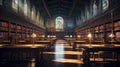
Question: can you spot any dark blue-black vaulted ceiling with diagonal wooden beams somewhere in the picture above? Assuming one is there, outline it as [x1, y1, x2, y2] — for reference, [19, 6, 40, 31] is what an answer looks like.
[30, 0, 87, 18]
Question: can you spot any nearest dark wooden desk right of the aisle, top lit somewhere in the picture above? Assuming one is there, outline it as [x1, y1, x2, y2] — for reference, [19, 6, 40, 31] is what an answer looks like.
[79, 45, 120, 62]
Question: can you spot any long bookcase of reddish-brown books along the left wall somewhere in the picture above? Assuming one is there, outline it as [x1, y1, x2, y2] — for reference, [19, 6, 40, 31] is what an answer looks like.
[0, 20, 42, 43]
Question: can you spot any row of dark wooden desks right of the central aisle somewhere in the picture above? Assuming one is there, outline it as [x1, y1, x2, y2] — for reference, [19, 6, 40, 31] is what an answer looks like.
[70, 40, 120, 62]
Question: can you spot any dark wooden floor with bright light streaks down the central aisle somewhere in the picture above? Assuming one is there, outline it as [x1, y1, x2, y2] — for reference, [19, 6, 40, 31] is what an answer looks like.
[0, 40, 120, 67]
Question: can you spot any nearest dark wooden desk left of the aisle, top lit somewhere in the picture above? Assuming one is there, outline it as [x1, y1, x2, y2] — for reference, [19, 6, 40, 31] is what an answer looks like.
[0, 44, 44, 61]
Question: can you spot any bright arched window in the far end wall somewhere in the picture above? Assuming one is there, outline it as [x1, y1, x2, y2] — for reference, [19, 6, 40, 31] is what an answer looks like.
[56, 16, 64, 31]
